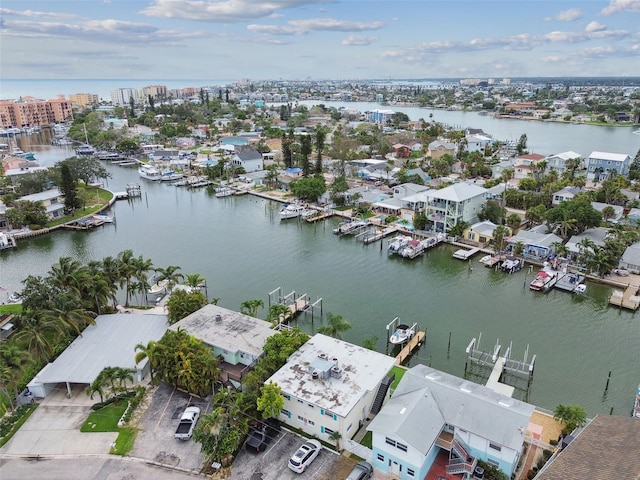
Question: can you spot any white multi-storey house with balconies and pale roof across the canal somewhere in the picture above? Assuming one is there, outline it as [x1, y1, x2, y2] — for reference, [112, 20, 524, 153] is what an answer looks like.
[425, 182, 487, 233]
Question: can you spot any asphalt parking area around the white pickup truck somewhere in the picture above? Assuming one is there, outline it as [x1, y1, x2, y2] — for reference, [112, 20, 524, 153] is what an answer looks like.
[131, 384, 210, 471]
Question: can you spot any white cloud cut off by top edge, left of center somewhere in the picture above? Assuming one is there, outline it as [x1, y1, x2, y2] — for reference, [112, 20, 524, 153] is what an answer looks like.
[140, 0, 330, 23]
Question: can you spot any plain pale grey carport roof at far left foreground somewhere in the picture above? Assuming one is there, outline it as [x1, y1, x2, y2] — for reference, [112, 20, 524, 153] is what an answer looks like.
[30, 313, 167, 384]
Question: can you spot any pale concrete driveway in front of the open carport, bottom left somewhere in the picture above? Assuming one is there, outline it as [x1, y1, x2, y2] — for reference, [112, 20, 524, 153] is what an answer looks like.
[0, 385, 118, 456]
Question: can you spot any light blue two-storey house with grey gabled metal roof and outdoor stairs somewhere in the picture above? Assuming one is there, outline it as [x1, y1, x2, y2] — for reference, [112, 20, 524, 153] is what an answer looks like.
[367, 365, 534, 480]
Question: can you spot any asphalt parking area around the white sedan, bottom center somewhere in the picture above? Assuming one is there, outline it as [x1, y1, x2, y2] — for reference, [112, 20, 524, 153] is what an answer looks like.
[229, 430, 356, 480]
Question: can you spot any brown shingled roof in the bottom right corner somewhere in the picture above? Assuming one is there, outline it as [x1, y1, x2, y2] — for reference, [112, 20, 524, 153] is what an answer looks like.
[535, 415, 640, 480]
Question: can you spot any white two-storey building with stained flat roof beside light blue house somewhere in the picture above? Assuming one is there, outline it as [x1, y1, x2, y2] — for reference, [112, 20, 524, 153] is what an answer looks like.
[266, 334, 395, 443]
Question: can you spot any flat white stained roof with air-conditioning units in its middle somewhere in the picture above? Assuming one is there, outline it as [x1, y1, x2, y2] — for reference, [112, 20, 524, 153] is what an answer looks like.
[265, 333, 395, 417]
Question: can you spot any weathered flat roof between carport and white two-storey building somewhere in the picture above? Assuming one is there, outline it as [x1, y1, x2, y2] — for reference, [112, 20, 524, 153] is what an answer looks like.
[170, 304, 277, 357]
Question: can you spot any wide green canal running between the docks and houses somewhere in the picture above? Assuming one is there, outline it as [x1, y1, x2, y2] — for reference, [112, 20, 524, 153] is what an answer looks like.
[0, 123, 640, 415]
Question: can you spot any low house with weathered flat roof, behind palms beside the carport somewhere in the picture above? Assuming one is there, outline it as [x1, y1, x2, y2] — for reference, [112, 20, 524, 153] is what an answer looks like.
[169, 304, 277, 386]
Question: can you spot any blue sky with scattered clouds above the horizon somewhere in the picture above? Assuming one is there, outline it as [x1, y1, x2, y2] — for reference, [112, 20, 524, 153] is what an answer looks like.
[0, 0, 640, 80]
